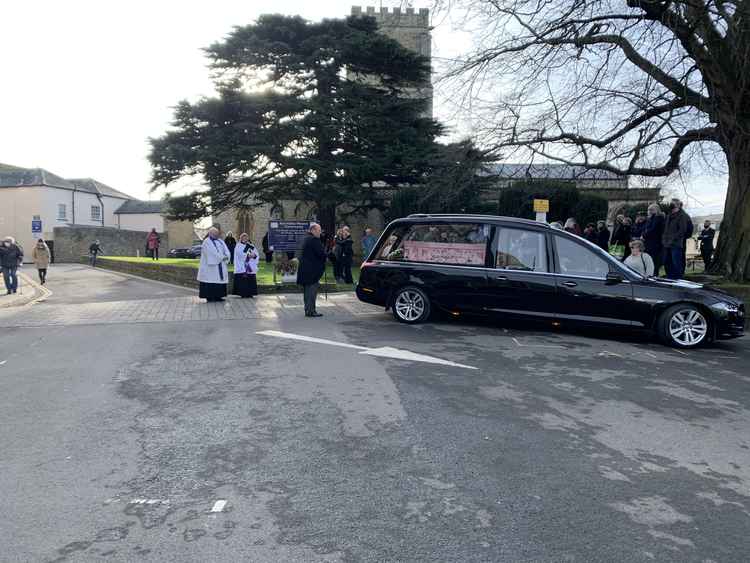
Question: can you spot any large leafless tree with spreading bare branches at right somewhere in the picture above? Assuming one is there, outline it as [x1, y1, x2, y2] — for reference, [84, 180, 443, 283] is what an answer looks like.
[446, 0, 750, 280]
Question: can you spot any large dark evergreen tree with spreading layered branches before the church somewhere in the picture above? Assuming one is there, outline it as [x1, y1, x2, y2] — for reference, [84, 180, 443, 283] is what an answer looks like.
[149, 15, 442, 234]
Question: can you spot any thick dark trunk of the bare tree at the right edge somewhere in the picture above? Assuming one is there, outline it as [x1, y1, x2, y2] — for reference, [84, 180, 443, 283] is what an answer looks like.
[711, 136, 750, 281]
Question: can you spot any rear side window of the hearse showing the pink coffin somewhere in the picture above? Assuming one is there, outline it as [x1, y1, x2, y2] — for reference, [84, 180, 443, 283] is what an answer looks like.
[377, 223, 490, 266]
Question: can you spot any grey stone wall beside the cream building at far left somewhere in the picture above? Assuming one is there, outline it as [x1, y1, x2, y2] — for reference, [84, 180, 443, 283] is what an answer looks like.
[53, 225, 169, 262]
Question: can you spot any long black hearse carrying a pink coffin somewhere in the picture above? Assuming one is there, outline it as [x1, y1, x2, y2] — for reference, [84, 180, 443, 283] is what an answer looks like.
[357, 215, 745, 348]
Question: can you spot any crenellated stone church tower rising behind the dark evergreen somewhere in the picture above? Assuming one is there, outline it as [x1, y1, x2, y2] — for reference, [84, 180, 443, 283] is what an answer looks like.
[352, 6, 433, 117]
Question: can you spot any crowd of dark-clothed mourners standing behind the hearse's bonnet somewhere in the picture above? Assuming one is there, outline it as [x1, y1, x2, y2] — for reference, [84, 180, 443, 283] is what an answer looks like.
[552, 199, 716, 279]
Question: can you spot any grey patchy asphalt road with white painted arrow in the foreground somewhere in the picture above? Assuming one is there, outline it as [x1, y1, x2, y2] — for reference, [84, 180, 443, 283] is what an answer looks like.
[0, 267, 750, 562]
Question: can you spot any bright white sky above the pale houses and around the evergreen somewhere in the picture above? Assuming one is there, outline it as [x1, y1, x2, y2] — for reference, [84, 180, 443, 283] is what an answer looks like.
[0, 0, 725, 213]
